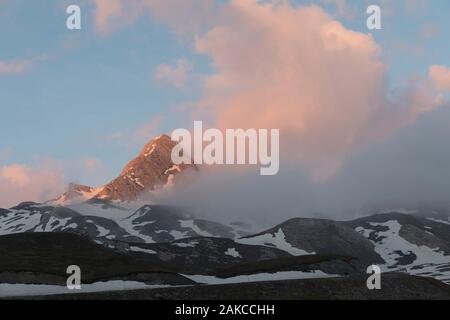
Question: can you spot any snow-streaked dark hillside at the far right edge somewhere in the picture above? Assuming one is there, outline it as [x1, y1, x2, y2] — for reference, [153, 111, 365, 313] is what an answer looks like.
[349, 212, 450, 283]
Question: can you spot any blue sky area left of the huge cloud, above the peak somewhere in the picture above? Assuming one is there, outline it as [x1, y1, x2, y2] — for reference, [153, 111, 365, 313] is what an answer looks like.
[0, 1, 200, 182]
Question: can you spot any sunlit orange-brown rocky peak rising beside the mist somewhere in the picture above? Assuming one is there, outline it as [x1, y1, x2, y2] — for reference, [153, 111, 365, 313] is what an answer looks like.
[95, 135, 197, 201]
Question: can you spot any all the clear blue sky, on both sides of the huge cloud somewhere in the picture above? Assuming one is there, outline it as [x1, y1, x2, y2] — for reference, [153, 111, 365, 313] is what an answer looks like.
[0, 0, 450, 183]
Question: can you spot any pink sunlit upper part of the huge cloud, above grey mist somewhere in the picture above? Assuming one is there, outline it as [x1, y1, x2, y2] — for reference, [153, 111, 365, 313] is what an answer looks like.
[191, 0, 442, 179]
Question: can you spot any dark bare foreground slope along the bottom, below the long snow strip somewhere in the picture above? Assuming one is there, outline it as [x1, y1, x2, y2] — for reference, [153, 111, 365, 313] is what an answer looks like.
[12, 273, 450, 300]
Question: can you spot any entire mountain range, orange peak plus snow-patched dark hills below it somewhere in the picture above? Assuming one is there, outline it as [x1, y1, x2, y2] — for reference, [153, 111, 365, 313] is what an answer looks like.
[0, 135, 450, 296]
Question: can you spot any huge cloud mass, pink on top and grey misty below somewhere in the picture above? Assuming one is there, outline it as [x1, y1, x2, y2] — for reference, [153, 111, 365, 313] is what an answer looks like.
[146, 1, 450, 222]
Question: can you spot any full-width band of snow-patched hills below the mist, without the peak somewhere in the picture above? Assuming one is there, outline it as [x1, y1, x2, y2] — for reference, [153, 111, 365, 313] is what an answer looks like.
[0, 199, 450, 283]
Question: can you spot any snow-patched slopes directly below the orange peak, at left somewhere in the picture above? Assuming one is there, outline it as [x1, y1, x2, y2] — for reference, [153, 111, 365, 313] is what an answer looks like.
[0, 200, 243, 243]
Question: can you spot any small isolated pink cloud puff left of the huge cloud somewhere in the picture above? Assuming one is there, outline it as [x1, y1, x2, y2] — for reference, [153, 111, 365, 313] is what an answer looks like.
[155, 59, 192, 89]
